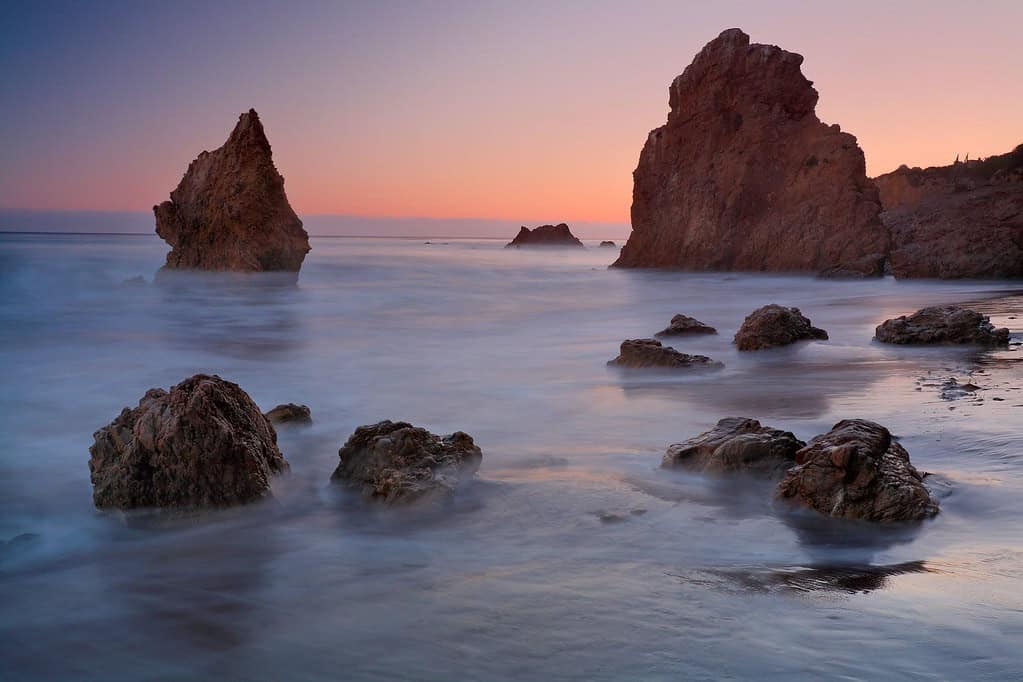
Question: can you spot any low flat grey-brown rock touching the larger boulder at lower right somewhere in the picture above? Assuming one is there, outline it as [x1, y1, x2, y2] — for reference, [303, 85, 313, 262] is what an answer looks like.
[661, 417, 806, 476]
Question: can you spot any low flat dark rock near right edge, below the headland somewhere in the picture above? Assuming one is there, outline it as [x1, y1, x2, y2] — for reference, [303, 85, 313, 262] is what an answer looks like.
[874, 306, 1009, 346]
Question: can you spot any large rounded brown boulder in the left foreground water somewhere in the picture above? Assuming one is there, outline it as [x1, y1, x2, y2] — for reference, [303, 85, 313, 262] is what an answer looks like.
[89, 374, 287, 509]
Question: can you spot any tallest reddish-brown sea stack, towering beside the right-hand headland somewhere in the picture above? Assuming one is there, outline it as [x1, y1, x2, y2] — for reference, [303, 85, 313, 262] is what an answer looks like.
[615, 29, 888, 275]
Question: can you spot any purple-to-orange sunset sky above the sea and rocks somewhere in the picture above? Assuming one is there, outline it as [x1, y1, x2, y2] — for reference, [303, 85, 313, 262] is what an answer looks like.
[0, 0, 1023, 229]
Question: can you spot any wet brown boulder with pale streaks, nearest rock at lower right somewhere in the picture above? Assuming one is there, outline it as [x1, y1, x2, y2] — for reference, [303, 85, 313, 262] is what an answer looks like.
[777, 419, 938, 521]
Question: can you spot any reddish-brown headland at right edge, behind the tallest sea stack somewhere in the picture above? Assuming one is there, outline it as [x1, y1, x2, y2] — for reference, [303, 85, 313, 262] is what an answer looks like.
[875, 145, 1023, 279]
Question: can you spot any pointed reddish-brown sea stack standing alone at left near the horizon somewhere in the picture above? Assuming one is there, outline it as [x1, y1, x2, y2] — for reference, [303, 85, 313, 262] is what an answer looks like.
[152, 109, 309, 272]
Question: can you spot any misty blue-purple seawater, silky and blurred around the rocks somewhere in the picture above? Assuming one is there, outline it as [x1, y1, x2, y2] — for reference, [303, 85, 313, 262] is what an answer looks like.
[0, 234, 1023, 681]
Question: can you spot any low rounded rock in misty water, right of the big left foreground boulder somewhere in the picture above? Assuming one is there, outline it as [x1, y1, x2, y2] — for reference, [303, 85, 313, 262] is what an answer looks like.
[330, 421, 483, 502]
